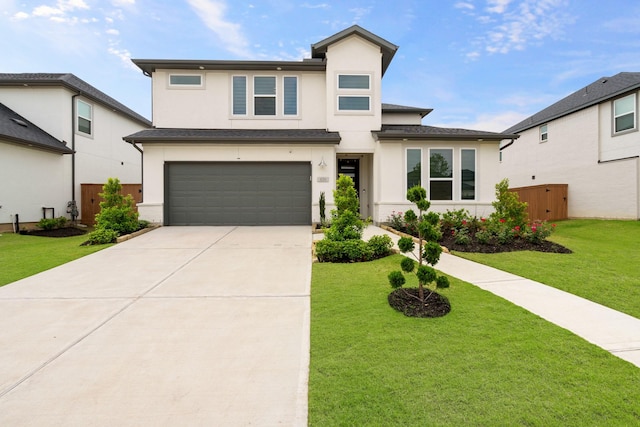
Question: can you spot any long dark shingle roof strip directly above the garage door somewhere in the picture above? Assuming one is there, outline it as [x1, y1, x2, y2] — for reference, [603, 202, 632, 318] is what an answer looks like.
[123, 128, 340, 144]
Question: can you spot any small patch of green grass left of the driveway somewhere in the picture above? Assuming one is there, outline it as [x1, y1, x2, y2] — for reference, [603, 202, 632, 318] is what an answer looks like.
[0, 233, 110, 286]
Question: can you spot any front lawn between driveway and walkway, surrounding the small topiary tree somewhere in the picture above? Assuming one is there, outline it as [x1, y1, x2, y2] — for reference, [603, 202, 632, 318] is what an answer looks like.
[309, 255, 640, 426]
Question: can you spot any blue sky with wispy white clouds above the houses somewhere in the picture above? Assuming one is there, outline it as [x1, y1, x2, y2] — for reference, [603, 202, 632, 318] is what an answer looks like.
[0, 0, 640, 131]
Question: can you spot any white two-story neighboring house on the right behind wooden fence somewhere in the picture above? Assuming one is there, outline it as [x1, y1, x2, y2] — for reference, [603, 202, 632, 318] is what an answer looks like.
[500, 73, 640, 219]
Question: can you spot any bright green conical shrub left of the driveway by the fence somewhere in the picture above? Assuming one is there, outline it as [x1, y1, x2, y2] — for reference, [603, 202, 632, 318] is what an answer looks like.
[96, 178, 140, 235]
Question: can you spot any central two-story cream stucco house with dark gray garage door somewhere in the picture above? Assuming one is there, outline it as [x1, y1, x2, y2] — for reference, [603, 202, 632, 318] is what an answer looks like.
[125, 26, 517, 225]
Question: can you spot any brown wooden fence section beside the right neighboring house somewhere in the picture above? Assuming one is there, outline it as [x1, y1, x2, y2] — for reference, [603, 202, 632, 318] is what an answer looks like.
[509, 184, 569, 221]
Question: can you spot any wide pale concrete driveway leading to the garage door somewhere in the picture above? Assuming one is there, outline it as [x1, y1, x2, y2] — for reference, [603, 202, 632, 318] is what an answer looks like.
[0, 227, 311, 426]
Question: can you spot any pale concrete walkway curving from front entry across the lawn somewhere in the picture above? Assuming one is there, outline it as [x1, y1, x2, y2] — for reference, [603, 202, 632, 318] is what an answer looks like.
[363, 226, 640, 367]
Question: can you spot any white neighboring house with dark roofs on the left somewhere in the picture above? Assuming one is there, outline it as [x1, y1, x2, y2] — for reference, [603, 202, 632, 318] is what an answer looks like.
[0, 73, 151, 229]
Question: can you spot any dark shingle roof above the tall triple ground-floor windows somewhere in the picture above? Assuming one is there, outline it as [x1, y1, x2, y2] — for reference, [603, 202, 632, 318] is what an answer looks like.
[374, 125, 519, 141]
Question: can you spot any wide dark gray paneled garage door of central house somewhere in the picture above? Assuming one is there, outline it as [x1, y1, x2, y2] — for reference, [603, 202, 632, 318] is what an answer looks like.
[164, 162, 311, 225]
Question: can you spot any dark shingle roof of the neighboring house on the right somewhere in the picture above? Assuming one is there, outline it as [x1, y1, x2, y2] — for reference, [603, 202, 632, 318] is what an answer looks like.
[505, 73, 640, 133]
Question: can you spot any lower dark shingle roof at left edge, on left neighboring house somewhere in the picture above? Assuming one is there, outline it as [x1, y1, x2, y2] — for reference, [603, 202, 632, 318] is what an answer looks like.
[0, 103, 73, 154]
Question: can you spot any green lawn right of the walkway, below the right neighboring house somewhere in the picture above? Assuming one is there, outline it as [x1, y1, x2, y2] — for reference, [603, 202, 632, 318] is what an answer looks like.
[456, 220, 640, 318]
